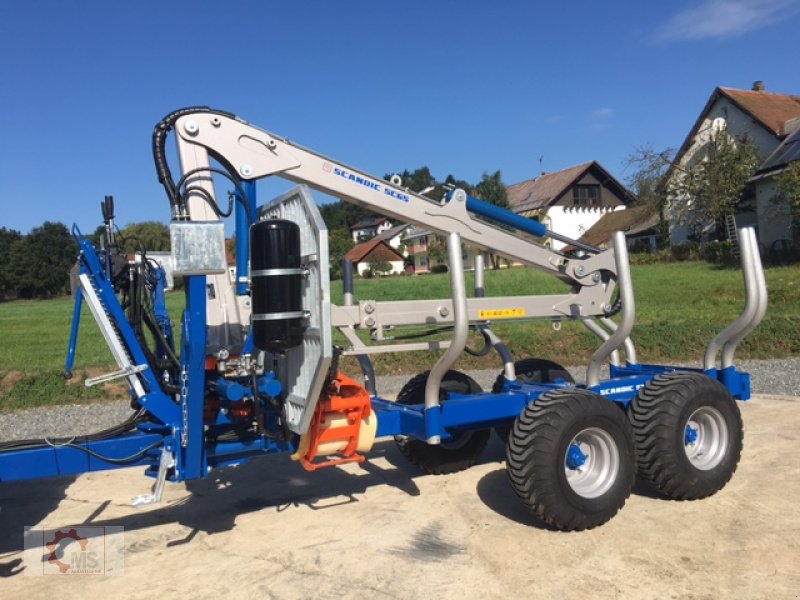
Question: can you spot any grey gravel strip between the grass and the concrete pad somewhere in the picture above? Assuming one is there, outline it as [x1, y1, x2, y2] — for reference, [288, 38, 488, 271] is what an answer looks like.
[0, 358, 800, 441]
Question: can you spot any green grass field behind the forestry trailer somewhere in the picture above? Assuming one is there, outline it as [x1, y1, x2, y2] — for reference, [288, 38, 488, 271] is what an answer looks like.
[0, 263, 800, 412]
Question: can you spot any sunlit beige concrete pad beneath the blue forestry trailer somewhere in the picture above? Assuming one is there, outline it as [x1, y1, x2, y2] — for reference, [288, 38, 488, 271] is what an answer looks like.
[0, 396, 800, 600]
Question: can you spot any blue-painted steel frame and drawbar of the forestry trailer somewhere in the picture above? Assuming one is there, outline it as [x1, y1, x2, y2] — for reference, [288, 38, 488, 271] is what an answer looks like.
[0, 209, 750, 482]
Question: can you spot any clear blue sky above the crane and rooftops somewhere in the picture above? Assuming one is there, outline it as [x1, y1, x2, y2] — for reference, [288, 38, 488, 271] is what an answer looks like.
[0, 0, 800, 233]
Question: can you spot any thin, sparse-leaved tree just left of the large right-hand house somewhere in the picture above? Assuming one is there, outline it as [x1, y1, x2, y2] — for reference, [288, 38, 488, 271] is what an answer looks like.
[626, 146, 675, 248]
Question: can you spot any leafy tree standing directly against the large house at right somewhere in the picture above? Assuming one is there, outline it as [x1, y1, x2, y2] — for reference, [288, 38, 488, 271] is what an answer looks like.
[671, 131, 761, 241]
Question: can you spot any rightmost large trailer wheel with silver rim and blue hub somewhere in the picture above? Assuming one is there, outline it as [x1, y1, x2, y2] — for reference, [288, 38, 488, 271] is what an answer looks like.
[628, 373, 744, 500]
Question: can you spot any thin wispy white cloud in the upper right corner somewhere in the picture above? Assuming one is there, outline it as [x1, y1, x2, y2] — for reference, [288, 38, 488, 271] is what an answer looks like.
[656, 0, 797, 41]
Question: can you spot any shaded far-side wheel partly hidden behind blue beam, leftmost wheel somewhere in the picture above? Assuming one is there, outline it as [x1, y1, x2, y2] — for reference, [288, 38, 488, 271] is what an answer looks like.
[395, 371, 491, 475]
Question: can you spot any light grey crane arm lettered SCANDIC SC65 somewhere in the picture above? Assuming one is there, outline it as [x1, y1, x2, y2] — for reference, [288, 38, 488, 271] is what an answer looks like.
[164, 110, 616, 302]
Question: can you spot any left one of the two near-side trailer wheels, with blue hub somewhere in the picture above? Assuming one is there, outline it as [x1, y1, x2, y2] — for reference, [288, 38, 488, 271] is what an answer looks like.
[506, 389, 635, 531]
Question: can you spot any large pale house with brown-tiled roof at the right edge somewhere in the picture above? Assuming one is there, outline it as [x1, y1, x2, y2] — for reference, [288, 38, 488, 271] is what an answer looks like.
[668, 81, 800, 249]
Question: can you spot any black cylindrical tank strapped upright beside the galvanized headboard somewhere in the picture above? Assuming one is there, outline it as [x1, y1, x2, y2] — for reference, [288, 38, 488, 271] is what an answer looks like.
[250, 219, 306, 352]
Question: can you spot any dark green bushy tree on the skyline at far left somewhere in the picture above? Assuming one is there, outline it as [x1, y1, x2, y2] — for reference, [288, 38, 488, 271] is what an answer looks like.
[9, 221, 77, 298]
